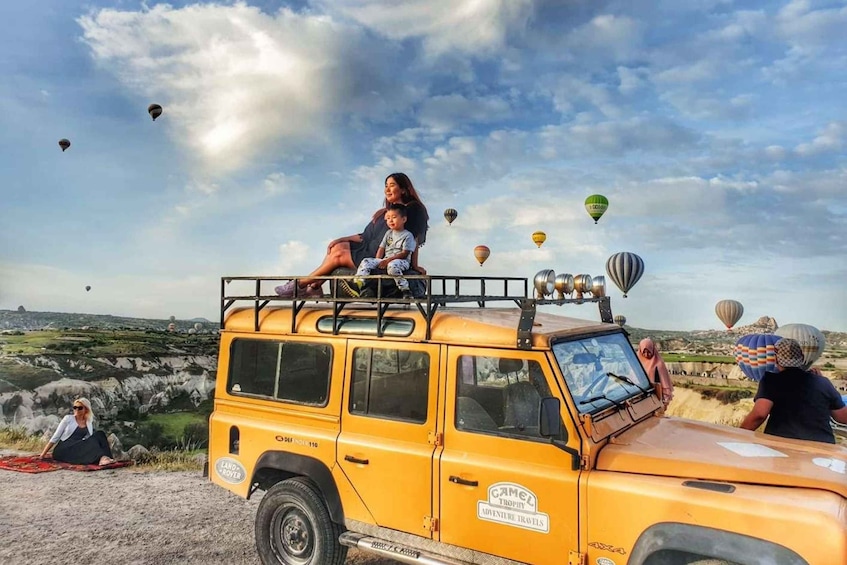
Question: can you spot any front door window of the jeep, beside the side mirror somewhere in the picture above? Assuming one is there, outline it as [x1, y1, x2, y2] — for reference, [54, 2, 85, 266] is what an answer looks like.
[455, 355, 552, 441]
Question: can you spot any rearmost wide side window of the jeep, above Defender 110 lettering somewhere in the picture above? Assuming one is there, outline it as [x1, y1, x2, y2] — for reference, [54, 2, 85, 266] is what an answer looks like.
[227, 339, 332, 406]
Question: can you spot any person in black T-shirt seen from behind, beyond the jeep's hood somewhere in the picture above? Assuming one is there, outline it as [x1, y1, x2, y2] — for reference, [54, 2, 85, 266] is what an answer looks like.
[740, 338, 847, 443]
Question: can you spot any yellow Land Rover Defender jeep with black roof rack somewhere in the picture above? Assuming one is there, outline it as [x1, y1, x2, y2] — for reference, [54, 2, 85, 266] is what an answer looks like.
[208, 276, 847, 565]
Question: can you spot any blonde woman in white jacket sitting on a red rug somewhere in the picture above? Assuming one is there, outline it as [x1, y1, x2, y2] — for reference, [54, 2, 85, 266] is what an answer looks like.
[39, 398, 115, 465]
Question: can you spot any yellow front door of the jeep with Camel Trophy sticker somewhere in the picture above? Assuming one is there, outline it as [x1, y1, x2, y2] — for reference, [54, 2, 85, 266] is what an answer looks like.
[436, 347, 579, 565]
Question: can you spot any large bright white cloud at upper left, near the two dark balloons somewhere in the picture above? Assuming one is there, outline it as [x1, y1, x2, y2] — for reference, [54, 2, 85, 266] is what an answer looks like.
[79, 2, 408, 174]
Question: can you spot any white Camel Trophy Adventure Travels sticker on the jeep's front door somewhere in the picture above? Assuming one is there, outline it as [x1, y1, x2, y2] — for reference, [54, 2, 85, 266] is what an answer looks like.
[476, 483, 550, 534]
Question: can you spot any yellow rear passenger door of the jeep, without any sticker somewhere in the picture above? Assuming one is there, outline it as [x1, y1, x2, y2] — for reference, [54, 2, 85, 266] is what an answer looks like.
[337, 340, 439, 535]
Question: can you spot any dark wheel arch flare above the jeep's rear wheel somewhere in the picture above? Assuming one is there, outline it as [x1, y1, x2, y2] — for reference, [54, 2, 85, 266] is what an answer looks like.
[248, 451, 344, 524]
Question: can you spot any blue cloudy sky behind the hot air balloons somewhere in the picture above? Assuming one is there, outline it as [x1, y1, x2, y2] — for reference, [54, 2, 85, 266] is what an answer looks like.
[0, 0, 847, 331]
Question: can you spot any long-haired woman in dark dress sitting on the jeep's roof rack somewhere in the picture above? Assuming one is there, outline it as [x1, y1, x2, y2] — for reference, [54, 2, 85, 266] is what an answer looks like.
[275, 173, 429, 298]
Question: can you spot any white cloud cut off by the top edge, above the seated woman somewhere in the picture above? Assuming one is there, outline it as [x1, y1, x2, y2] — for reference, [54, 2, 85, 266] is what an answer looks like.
[316, 0, 532, 56]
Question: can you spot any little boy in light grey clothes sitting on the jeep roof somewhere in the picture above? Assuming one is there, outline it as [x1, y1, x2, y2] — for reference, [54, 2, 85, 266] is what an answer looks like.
[353, 203, 417, 298]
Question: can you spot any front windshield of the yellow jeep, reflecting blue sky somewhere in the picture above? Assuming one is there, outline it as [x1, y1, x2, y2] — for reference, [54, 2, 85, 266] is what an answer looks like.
[553, 333, 653, 413]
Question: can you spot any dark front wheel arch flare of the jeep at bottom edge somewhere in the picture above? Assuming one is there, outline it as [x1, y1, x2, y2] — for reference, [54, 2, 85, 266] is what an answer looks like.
[627, 522, 809, 565]
